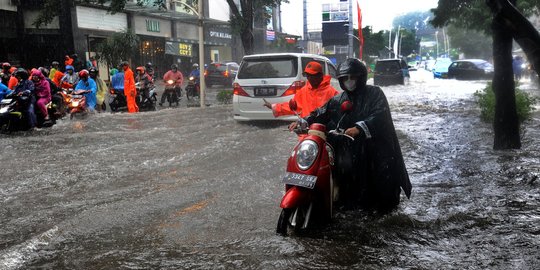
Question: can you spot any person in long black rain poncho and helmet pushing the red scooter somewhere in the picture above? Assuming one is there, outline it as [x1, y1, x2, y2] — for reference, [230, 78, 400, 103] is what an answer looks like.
[304, 58, 411, 213]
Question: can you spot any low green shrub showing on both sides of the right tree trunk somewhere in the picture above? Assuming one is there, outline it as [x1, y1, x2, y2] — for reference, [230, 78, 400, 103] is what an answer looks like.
[474, 83, 537, 123]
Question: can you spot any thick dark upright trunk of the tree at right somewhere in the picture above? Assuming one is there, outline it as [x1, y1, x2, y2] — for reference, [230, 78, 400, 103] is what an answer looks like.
[492, 0, 521, 149]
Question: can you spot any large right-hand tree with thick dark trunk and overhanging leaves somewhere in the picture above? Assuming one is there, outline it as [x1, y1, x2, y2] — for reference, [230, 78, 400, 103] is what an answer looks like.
[431, 0, 540, 149]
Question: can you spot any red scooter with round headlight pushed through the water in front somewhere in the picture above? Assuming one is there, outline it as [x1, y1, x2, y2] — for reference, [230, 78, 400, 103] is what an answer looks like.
[276, 100, 354, 235]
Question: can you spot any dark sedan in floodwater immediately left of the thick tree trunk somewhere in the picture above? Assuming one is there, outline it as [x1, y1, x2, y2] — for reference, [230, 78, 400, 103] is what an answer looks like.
[448, 59, 493, 80]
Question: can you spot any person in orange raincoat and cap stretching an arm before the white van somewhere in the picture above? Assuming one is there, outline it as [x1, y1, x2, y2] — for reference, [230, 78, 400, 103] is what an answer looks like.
[264, 61, 338, 117]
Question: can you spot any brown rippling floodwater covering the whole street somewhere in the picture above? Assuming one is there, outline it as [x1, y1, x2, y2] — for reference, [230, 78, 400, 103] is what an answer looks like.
[0, 70, 540, 269]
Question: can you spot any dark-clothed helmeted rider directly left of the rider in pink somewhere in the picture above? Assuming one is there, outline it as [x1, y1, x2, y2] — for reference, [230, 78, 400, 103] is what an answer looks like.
[12, 68, 37, 129]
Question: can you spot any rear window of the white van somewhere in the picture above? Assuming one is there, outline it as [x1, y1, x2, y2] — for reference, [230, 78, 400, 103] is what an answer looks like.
[238, 57, 298, 79]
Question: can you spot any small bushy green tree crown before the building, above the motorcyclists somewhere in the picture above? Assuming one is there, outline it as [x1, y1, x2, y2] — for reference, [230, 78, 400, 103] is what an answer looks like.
[96, 30, 139, 67]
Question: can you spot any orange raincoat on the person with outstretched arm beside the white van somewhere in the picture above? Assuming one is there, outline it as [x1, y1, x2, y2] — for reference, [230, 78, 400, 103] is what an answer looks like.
[272, 75, 338, 117]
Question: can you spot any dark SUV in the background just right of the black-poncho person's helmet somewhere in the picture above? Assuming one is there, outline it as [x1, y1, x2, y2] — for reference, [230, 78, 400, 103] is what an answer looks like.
[373, 58, 410, 86]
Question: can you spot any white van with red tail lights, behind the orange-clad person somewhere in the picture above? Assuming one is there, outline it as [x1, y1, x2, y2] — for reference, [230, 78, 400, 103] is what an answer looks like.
[232, 53, 340, 121]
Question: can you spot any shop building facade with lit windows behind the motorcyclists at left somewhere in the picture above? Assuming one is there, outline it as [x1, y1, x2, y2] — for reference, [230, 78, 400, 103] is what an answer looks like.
[0, 0, 241, 76]
